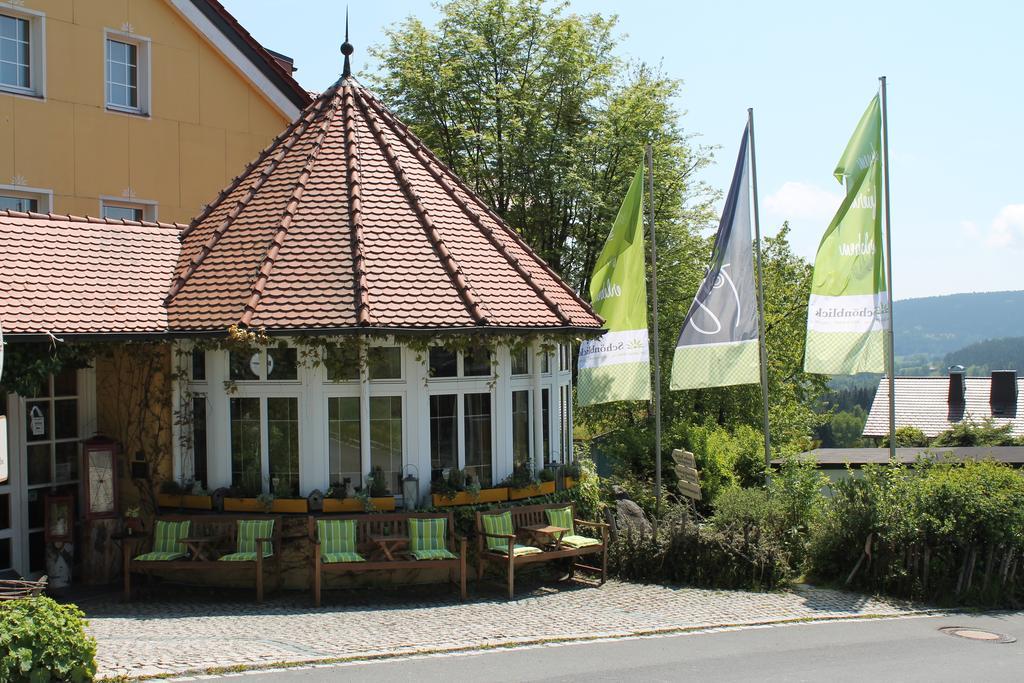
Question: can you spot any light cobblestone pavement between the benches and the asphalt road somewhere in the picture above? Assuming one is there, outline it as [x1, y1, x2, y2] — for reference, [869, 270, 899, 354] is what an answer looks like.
[80, 582, 921, 677]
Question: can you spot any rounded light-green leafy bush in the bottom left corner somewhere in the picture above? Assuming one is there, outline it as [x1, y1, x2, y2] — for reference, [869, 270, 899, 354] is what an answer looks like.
[0, 598, 96, 681]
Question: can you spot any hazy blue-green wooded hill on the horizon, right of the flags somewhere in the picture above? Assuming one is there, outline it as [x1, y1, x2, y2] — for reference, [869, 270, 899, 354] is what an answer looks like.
[893, 292, 1024, 358]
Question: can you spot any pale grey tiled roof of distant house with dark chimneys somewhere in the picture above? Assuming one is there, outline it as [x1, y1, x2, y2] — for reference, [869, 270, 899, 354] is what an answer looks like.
[863, 377, 1024, 436]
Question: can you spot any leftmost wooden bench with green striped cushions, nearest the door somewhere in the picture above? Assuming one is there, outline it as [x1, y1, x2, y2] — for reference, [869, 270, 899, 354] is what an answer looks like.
[124, 514, 282, 602]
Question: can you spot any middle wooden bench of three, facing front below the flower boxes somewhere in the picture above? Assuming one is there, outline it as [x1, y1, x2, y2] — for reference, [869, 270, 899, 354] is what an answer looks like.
[309, 512, 466, 607]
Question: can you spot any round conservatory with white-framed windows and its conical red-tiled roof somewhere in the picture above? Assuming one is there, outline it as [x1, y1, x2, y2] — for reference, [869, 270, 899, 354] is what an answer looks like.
[166, 72, 601, 505]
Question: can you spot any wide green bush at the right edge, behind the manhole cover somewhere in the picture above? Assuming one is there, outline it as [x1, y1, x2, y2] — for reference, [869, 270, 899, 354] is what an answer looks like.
[808, 461, 1024, 605]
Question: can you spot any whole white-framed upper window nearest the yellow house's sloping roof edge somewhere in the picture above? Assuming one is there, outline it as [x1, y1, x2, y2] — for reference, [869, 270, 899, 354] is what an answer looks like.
[103, 30, 150, 116]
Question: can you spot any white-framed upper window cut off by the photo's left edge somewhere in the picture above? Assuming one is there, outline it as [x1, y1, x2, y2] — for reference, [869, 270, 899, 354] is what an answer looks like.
[0, 5, 46, 97]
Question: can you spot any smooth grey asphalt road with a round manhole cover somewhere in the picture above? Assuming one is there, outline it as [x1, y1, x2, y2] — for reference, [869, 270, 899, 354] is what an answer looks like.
[237, 612, 1024, 683]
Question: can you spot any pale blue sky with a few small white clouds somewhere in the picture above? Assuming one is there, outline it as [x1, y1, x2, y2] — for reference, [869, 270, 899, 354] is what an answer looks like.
[224, 0, 1024, 299]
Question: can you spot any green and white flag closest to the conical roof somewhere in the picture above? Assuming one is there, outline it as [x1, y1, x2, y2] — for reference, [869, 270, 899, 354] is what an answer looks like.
[577, 164, 650, 405]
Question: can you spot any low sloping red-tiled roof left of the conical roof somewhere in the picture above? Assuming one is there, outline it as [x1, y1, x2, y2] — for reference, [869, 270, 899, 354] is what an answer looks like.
[0, 211, 185, 335]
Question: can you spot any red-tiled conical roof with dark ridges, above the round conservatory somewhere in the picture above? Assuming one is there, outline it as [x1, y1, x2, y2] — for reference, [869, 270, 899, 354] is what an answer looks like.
[167, 77, 601, 332]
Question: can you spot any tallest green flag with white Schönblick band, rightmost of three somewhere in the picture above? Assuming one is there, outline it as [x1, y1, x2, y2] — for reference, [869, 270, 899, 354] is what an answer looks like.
[804, 96, 889, 375]
